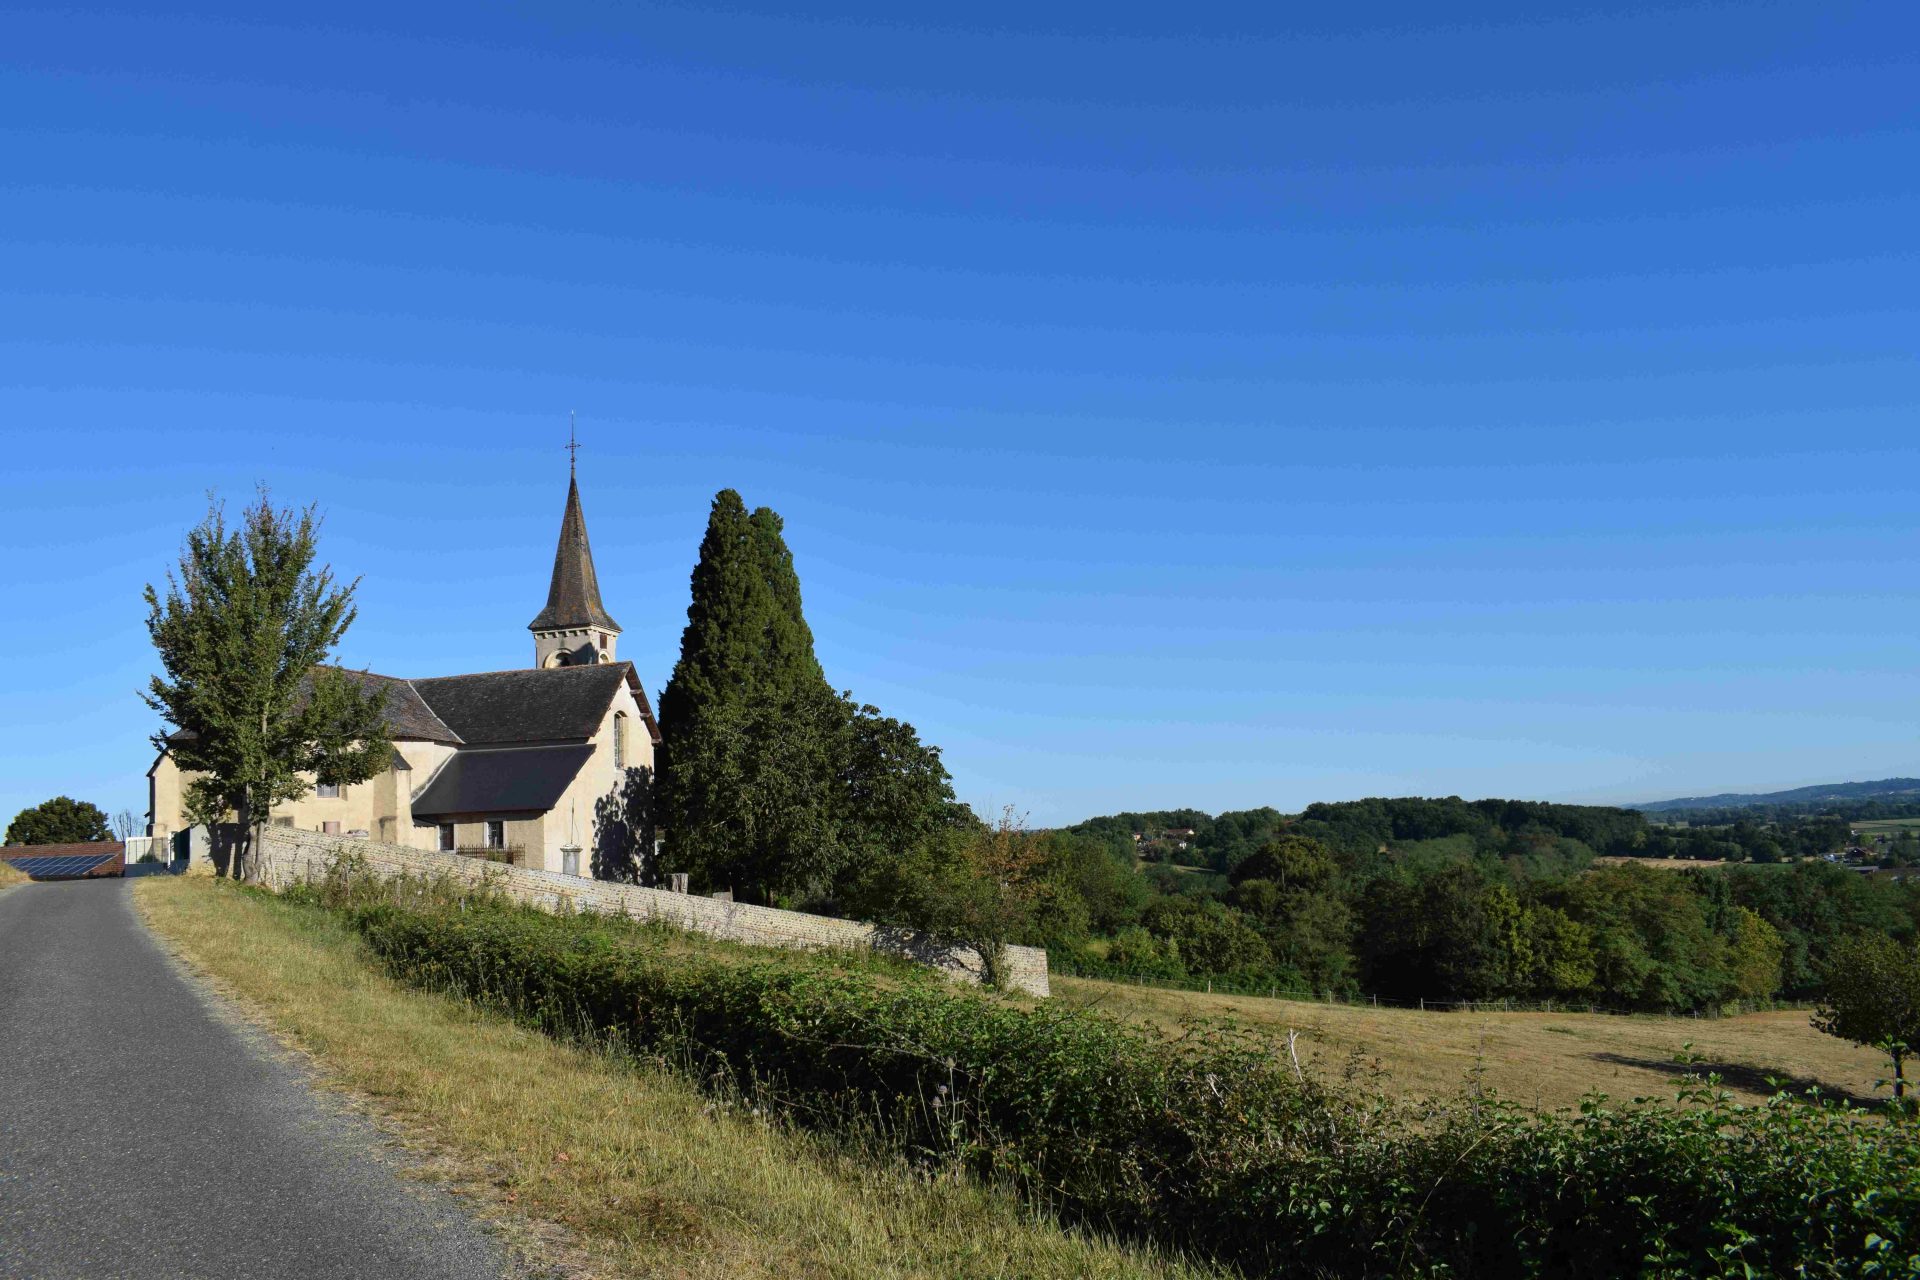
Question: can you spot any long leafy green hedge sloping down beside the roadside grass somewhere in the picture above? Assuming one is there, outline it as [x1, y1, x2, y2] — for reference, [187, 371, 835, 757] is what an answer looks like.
[326, 904, 1920, 1276]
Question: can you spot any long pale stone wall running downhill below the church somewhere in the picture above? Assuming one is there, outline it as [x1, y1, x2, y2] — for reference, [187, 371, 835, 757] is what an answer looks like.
[255, 827, 1050, 996]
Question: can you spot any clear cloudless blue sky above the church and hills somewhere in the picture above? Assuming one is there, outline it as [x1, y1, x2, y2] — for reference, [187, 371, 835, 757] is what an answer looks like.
[0, 4, 1920, 823]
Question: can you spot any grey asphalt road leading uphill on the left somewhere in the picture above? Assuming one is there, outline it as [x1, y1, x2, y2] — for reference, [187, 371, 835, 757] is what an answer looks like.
[0, 881, 513, 1280]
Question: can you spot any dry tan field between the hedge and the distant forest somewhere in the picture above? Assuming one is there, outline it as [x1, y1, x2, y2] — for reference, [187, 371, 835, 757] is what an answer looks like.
[1052, 975, 1885, 1109]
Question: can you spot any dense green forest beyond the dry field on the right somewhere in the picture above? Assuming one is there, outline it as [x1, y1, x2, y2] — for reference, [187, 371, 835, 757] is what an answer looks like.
[1021, 796, 1920, 1011]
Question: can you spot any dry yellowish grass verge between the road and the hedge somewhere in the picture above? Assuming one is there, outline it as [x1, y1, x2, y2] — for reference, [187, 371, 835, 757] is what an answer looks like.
[134, 877, 1212, 1280]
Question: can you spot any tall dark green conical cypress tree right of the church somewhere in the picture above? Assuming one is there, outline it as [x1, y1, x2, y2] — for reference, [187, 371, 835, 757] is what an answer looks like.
[659, 489, 839, 898]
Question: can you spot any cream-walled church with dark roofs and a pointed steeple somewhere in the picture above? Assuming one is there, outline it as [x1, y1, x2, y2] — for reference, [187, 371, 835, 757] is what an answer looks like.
[148, 478, 660, 875]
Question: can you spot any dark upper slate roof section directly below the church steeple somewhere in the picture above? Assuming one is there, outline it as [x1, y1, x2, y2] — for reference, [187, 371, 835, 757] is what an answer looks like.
[413, 662, 633, 747]
